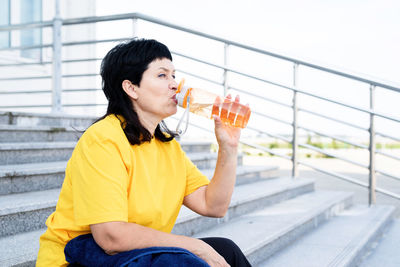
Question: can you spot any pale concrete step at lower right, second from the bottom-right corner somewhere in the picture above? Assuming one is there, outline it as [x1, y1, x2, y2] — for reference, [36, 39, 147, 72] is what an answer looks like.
[259, 205, 394, 267]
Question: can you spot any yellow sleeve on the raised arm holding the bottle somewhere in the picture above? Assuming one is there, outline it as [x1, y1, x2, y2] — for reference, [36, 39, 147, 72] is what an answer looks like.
[182, 151, 210, 196]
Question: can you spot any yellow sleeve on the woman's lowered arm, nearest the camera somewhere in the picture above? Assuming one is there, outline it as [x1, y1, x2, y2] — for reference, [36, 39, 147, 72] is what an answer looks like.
[67, 138, 128, 225]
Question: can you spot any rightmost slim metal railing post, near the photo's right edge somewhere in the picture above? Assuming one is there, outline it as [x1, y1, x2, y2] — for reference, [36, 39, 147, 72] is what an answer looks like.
[368, 84, 376, 206]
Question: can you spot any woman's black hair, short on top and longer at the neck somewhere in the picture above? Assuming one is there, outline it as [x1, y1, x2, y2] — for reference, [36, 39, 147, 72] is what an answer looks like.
[99, 38, 177, 145]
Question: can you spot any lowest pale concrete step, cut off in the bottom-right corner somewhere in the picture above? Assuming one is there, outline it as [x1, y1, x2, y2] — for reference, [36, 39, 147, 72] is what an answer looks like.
[359, 219, 400, 267]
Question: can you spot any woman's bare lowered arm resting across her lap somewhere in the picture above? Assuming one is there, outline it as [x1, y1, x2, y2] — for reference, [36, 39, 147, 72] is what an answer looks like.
[90, 222, 228, 266]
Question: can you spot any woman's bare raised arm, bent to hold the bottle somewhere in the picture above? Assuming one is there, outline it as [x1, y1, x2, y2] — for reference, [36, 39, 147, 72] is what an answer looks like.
[183, 97, 240, 217]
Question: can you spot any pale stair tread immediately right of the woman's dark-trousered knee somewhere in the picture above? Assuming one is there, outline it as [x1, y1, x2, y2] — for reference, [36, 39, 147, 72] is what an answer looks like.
[196, 191, 352, 255]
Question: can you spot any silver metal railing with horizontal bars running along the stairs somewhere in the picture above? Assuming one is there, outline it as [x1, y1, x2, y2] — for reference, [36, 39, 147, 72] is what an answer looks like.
[0, 12, 400, 204]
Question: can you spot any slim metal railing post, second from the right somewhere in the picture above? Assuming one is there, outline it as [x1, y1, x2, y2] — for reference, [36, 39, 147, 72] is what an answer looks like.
[292, 63, 299, 178]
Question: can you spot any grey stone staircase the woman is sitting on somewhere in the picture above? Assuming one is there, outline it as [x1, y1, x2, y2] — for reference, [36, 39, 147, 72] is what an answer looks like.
[0, 112, 400, 267]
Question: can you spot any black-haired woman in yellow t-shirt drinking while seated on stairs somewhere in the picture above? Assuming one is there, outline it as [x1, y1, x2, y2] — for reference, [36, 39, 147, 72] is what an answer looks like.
[37, 39, 249, 266]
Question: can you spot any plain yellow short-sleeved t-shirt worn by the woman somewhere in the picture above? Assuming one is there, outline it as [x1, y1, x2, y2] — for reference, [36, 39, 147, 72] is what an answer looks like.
[36, 115, 209, 266]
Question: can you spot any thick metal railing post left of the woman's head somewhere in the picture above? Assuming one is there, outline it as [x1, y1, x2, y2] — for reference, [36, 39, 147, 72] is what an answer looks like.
[52, 0, 62, 113]
